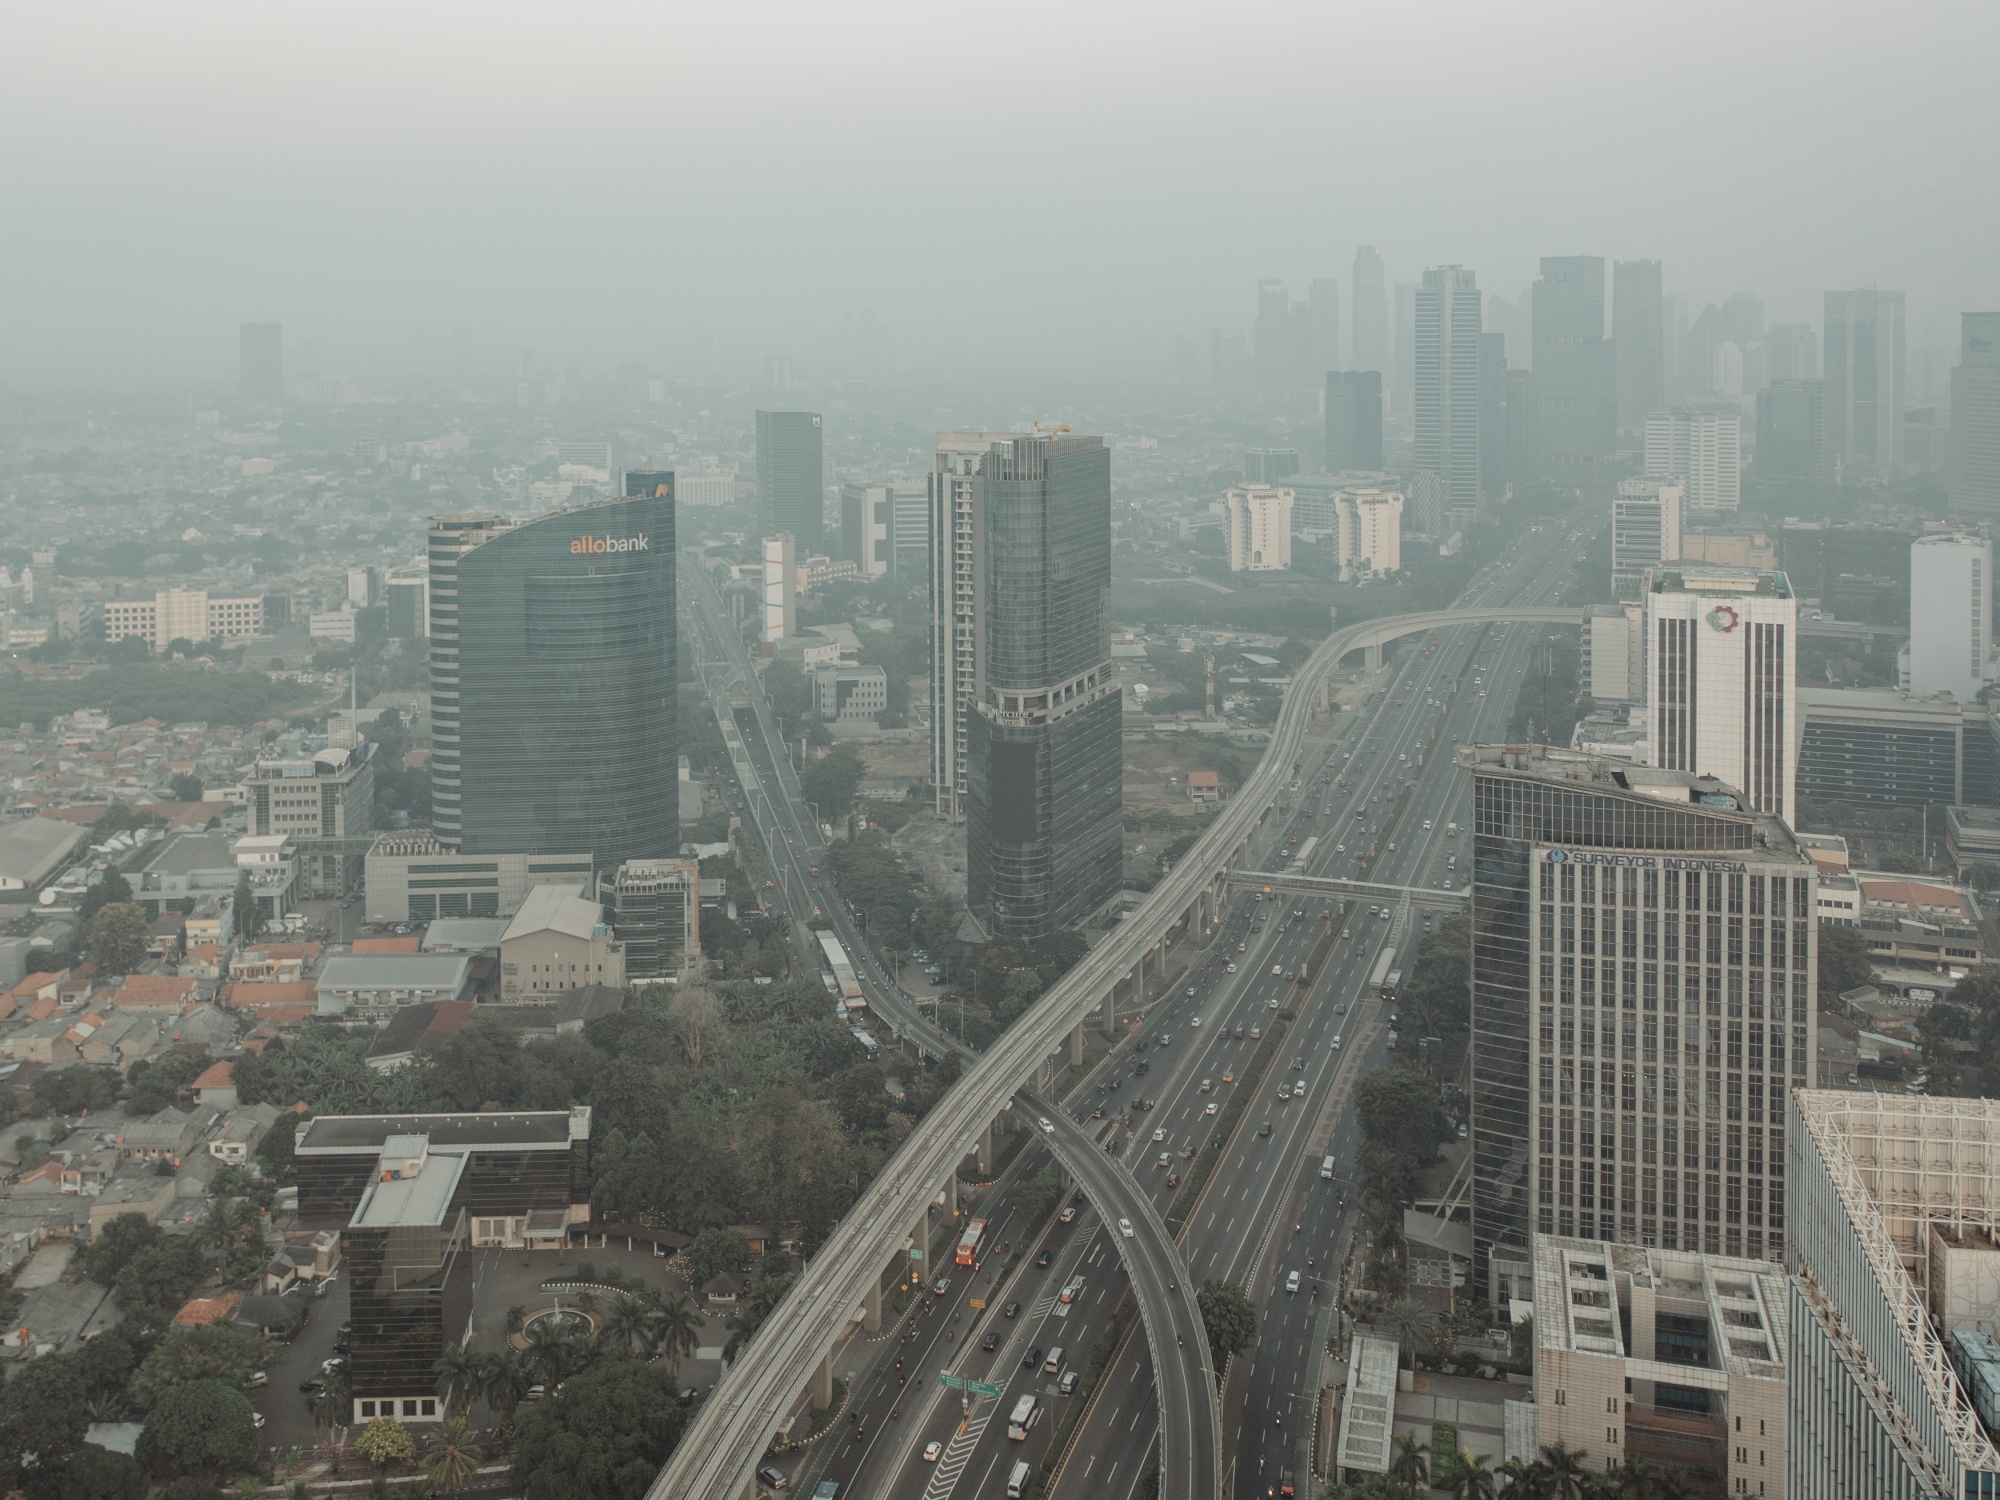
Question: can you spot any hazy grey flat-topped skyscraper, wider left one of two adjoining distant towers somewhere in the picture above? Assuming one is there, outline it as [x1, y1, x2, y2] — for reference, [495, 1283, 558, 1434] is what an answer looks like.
[1534, 256, 1618, 492]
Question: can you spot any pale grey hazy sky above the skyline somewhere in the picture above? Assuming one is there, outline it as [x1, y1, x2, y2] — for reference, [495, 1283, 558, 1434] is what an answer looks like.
[0, 0, 2000, 386]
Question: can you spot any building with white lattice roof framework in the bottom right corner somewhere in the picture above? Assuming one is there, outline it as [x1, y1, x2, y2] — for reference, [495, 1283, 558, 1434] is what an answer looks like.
[1782, 1088, 2000, 1500]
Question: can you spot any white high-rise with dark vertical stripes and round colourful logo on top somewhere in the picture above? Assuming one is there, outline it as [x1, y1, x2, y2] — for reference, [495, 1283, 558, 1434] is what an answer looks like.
[1644, 562, 1798, 822]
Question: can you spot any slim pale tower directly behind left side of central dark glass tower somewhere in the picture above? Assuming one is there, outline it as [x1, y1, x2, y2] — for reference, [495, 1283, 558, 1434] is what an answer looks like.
[930, 432, 1020, 822]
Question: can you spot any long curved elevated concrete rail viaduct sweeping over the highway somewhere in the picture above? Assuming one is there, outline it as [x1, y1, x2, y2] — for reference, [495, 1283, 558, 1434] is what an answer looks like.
[646, 608, 1582, 1500]
